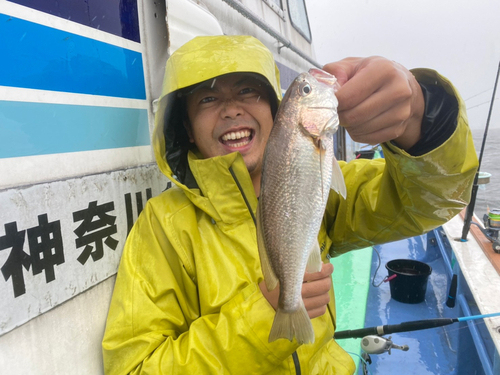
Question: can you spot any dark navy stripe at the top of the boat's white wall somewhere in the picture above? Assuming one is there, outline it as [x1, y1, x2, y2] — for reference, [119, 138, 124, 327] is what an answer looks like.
[5, 0, 140, 42]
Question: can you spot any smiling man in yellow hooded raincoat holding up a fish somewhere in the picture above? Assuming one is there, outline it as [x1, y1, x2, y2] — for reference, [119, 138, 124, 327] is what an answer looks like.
[103, 36, 478, 375]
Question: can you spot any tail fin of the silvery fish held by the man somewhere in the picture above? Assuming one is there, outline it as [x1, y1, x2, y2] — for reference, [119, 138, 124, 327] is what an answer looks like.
[269, 303, 314, 344]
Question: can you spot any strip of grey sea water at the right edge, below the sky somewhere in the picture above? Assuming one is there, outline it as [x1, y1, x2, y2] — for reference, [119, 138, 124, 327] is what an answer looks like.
[472, 125, 500, 220]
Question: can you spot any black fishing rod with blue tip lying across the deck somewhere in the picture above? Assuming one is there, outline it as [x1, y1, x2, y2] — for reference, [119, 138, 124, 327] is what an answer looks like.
[333, 312, 500, 340]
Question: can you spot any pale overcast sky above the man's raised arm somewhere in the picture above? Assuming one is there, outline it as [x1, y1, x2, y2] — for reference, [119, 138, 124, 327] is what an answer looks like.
[306, 0, 500, 129]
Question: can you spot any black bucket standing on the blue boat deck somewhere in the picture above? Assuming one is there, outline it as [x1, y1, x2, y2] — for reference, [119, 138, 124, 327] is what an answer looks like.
[385, 259, 432, 303]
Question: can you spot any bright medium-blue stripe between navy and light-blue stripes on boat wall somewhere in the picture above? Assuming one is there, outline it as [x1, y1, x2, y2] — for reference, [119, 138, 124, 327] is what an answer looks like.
[0, 14, 146, 99]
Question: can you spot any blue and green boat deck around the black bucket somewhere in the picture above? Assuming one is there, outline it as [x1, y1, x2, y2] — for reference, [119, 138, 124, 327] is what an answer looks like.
[332, 219, 500, 375]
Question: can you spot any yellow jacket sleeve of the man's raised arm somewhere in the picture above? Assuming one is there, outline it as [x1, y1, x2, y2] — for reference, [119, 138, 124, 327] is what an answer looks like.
[326, 69, 478, 256]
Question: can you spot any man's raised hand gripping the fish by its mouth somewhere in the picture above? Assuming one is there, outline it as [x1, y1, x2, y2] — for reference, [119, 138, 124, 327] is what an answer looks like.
[324, 56, 424, 149]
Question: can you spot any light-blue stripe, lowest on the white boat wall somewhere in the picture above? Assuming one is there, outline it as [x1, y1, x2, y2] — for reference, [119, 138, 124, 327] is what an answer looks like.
[0, 101, 150, 158]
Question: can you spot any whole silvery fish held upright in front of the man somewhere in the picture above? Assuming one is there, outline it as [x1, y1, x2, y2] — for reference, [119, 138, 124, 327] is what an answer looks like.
[257, 69, 346, 343]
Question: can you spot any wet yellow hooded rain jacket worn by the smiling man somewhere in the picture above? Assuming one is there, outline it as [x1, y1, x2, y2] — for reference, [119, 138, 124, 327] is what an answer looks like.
[103, 36, 477, 375]
